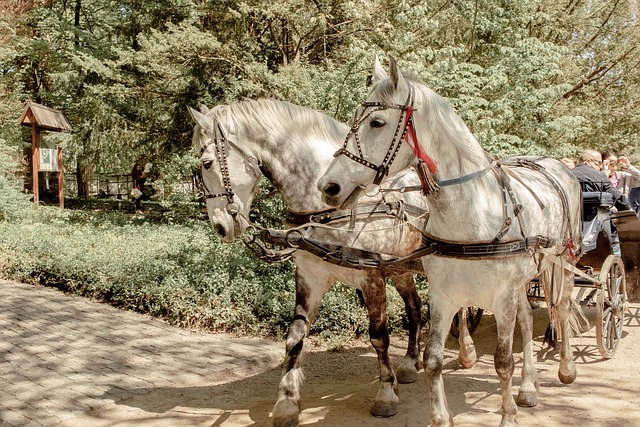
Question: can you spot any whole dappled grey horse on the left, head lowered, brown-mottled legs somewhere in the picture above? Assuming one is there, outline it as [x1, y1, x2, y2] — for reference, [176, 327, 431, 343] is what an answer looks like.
[189, 100, 442, 426]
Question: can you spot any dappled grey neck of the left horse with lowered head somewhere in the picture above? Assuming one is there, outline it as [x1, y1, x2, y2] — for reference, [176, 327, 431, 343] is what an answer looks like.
[230, 107, 346, 212]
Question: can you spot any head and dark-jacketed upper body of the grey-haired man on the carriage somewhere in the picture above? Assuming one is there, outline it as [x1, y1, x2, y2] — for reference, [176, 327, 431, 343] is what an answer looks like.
[572, 150, 631, 211]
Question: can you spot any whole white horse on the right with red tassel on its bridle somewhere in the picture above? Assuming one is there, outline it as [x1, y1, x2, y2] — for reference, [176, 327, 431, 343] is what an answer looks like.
[318, 59, 581, 426]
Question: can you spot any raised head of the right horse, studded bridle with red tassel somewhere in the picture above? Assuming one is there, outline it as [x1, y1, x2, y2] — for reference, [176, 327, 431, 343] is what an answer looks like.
[318, 57, 417, 206]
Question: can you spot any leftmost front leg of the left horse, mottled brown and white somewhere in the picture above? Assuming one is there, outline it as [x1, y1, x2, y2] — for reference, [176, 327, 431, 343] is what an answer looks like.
[272, 265, 331, 427]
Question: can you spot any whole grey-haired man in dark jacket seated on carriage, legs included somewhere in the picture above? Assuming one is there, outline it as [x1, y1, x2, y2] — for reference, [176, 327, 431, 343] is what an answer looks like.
[573, 150, 630, 256]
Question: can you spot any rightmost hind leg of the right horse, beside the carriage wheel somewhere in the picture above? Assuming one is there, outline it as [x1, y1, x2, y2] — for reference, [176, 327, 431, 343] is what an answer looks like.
[556, 269, 580, 384]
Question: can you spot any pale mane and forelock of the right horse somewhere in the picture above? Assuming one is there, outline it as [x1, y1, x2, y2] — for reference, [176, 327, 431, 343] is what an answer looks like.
[372, 73, 487, 164]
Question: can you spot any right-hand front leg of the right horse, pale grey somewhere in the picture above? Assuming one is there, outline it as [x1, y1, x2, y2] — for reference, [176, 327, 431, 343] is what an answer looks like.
[493, 295, 519, 427]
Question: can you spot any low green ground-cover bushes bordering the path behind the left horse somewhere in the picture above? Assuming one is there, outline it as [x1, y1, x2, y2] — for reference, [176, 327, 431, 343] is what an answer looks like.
[0, 187, 428, 345]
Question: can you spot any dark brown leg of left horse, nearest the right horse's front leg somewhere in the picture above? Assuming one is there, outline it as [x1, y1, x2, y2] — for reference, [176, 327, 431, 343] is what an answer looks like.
[393, 273, 422, 384]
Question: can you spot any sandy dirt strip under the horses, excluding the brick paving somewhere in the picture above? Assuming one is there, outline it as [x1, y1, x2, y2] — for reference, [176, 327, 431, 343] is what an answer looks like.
[71, 305, 640, 427]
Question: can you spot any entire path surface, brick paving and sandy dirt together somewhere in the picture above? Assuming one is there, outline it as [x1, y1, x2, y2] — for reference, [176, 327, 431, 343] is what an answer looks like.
[5, 281, 640, 427]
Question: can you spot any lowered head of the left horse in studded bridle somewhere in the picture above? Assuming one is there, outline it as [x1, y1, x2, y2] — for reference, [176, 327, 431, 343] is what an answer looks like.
[189, 106, 261, 243]
